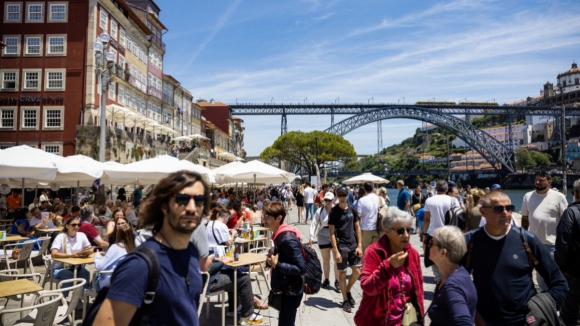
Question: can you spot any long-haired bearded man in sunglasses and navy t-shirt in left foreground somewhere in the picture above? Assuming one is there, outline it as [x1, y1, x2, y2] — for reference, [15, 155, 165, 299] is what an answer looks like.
[93, 171, 209, 326]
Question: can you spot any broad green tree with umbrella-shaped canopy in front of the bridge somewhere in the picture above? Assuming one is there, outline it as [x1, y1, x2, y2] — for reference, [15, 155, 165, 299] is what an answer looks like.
[260, 130, 357, 175]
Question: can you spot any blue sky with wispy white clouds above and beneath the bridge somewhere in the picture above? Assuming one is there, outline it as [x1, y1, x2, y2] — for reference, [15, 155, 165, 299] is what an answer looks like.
[157, 0, 580, 156]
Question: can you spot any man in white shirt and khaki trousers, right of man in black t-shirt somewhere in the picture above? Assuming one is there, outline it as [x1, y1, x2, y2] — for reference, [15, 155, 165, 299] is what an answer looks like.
[357, 181, 381, 257]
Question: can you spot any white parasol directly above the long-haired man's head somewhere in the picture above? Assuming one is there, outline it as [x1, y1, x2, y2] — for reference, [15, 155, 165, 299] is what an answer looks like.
[101, 155, 216, 185]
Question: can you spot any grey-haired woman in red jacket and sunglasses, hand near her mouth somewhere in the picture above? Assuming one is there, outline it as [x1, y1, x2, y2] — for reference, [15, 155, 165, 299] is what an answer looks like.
[354, 207, 424, 326]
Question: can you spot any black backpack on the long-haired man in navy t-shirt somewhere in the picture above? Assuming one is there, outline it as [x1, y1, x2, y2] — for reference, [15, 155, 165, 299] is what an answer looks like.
[83, 246, 159, 326]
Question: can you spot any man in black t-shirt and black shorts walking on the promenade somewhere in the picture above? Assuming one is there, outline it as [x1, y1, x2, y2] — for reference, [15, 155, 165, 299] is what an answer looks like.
[328, 188, 360, 312]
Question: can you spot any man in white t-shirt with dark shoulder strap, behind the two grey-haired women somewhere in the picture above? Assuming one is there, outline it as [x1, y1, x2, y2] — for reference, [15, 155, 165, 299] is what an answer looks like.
[423, 180, 459, 283]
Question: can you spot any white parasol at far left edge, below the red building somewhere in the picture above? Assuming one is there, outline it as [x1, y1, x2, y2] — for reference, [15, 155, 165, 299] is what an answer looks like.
[0, 145, 59, 180]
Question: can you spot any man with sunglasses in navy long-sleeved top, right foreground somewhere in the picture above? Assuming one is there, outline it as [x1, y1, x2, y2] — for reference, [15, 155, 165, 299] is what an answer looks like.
[462, 192, 567, 326]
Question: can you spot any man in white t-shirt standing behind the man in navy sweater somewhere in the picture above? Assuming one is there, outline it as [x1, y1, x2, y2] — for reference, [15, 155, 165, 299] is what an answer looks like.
[521, 171, 568, 291]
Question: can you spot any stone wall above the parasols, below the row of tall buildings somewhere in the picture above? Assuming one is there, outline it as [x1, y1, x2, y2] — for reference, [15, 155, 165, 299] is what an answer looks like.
[76, 125, 172, 163]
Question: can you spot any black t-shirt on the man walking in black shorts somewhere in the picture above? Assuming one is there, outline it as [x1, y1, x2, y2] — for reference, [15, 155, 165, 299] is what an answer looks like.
[328, 205, 360, 250]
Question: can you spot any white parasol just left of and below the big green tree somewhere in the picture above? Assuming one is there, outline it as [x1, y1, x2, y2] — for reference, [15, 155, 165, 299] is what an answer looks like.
[216, 160, 296, 183]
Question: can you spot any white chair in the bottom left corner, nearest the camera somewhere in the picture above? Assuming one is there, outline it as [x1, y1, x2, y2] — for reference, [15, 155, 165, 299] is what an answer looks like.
[0, 293, 62, 326]
